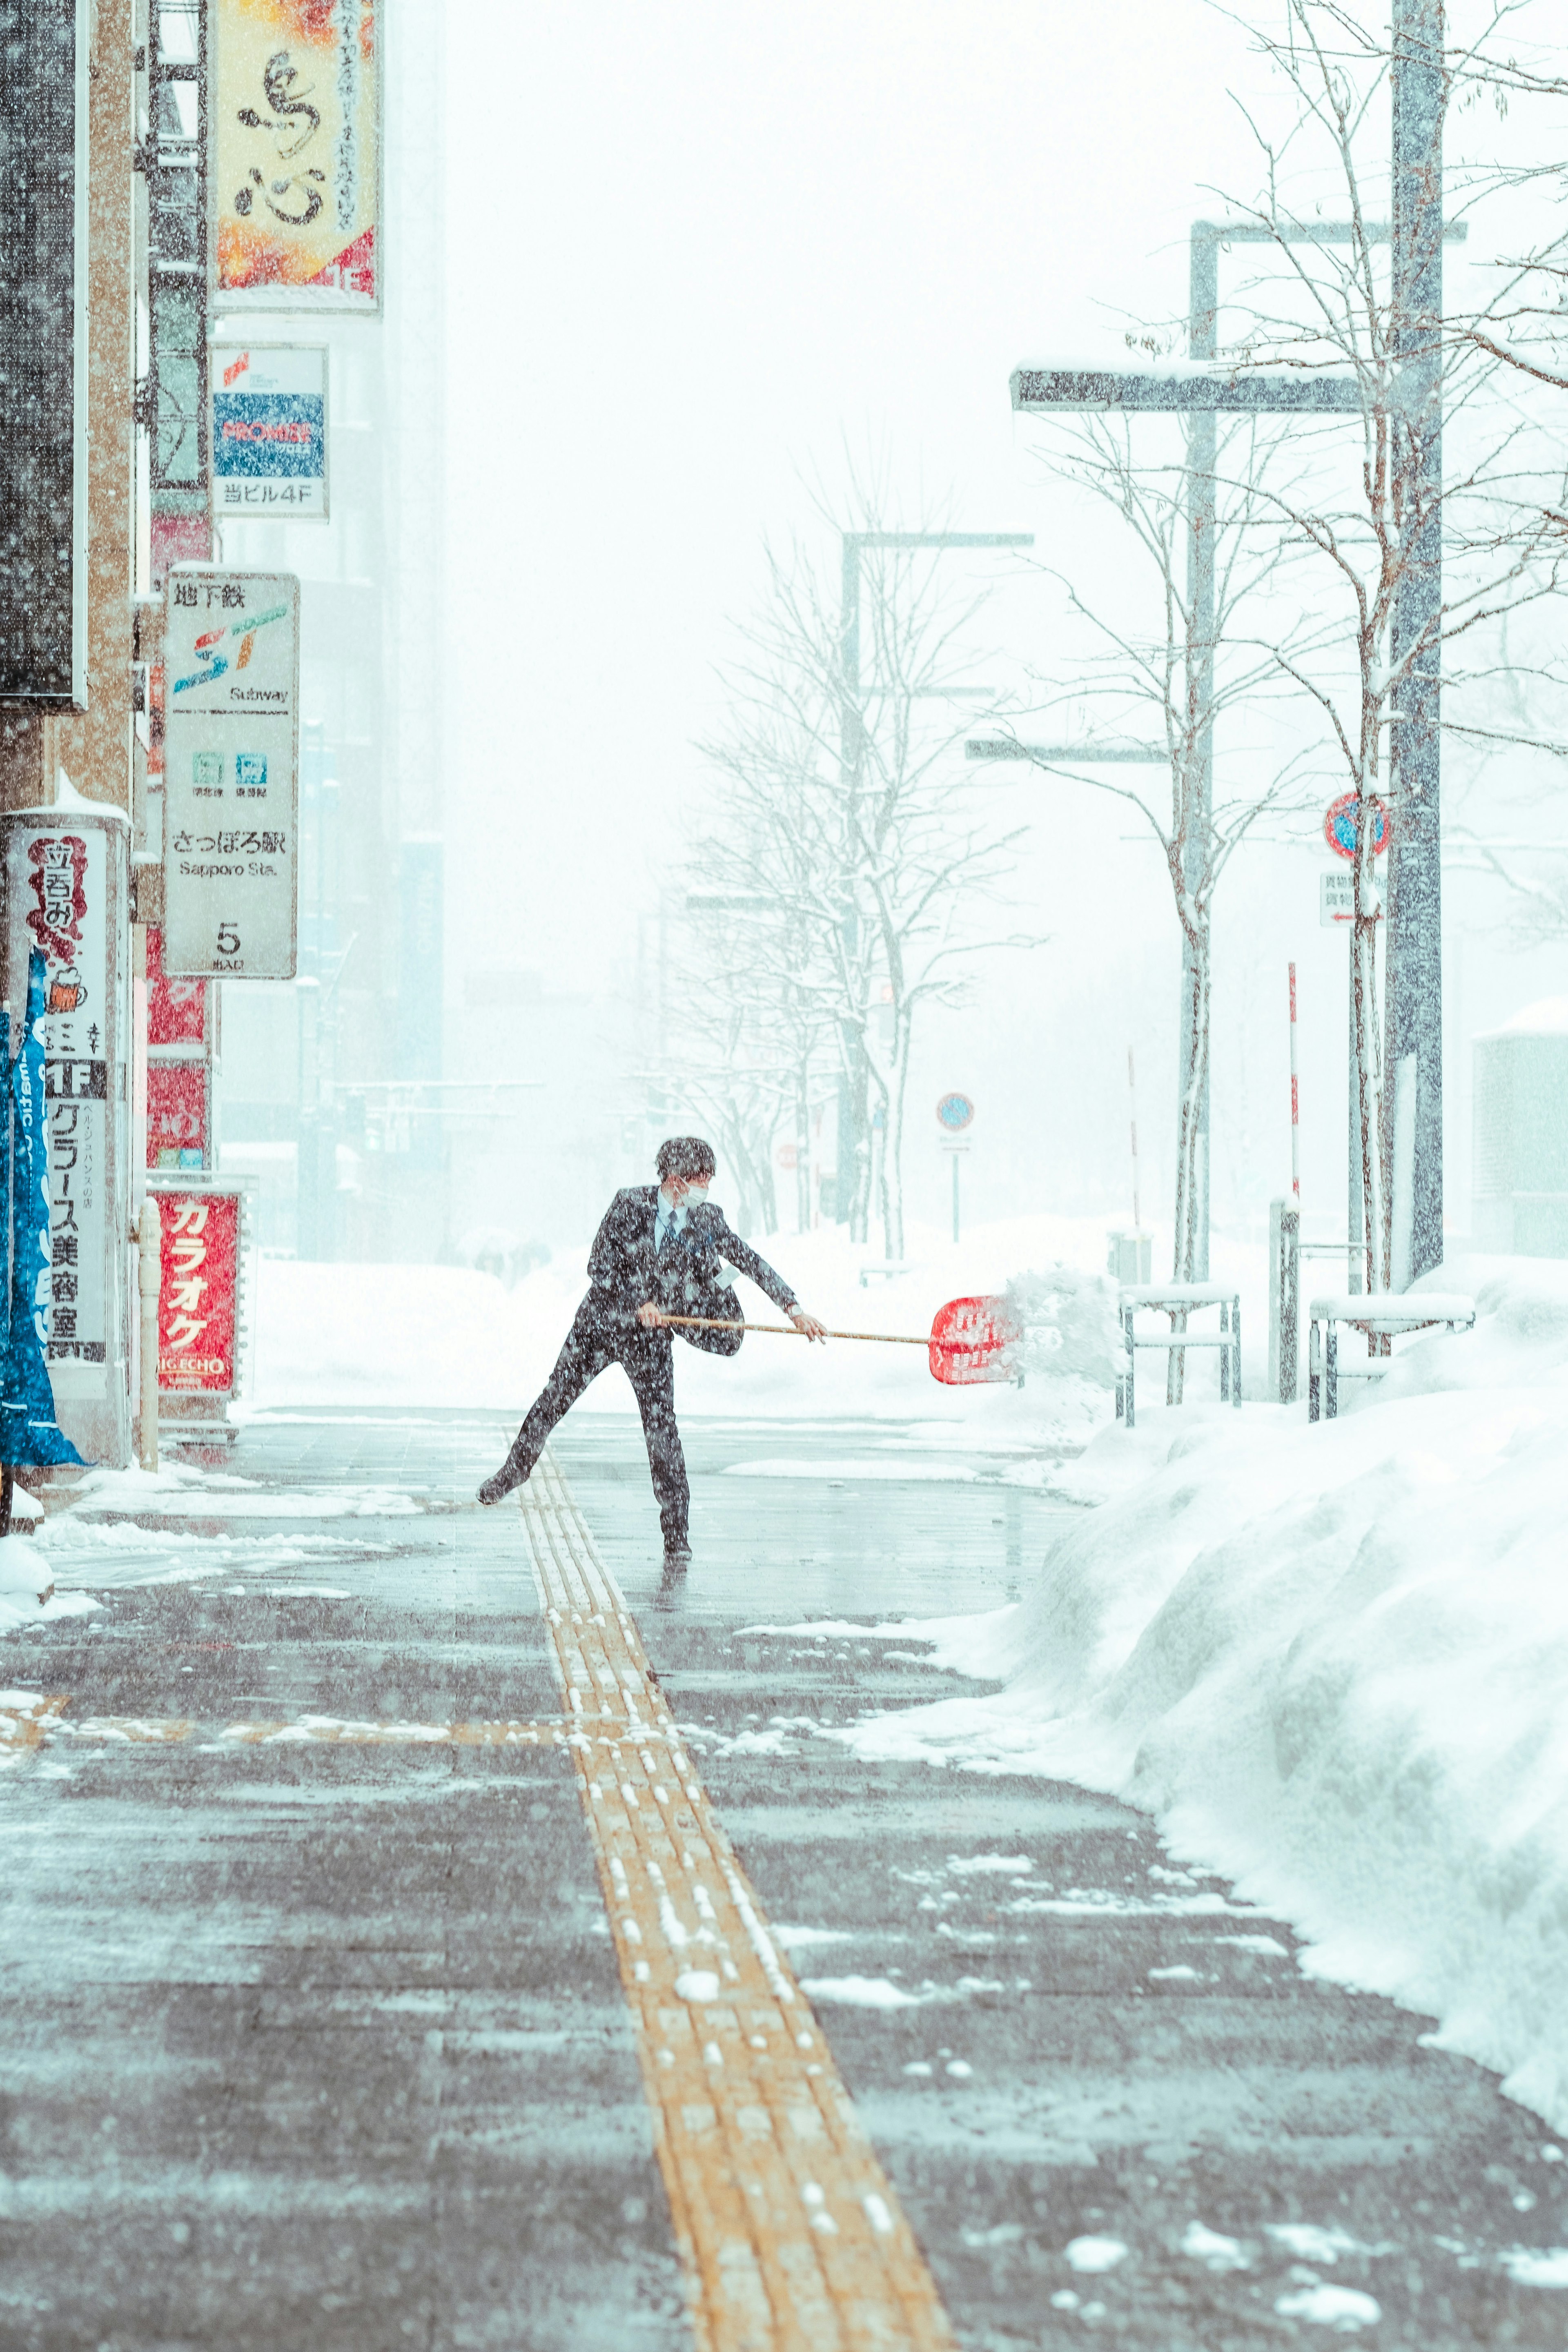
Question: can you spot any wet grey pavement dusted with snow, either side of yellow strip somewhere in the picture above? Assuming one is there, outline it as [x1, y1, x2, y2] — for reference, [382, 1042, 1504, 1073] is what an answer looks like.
[0, 1409, 1568, 2352]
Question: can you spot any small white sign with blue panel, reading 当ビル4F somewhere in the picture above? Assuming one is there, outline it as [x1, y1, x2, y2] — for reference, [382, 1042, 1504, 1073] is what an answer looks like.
[209, 343, 327, 522]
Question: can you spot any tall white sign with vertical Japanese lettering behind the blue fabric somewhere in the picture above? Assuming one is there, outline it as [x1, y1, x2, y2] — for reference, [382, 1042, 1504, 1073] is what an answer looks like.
[0, 809, 129, 1461]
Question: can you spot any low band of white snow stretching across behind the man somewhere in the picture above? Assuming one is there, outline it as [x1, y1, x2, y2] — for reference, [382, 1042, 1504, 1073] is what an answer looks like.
[254, 1216, 1267, 1444]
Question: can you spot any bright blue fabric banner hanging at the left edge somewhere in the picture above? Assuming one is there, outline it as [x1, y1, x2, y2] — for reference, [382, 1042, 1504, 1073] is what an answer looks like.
[0, 948, 82, 1463]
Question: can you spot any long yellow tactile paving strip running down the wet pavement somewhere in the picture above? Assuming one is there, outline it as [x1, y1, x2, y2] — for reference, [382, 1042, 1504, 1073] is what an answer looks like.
[522, 1454, 954, 2352]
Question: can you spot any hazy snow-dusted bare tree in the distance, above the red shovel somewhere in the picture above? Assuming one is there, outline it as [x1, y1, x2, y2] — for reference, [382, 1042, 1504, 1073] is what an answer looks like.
[701, 503, 1034, 1258]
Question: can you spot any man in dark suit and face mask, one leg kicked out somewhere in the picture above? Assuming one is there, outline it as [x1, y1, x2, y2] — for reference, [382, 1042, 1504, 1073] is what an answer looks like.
[479, 1136, 825, 1571]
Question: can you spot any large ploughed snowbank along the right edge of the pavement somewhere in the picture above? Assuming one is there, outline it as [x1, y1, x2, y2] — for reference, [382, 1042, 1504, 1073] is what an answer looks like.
[851, 1261, 1568, 2131]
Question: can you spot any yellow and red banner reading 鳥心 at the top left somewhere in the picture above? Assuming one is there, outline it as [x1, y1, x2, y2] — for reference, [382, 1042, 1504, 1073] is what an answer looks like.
[209, 0, 381, 310]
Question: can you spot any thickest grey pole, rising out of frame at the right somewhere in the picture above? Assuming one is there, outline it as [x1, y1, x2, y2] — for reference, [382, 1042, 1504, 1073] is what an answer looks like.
[1382, 0, 1443, 1291]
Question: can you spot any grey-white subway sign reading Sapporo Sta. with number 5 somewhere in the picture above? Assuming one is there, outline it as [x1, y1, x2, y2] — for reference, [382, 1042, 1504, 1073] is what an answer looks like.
[162, 564, 298, 981]
